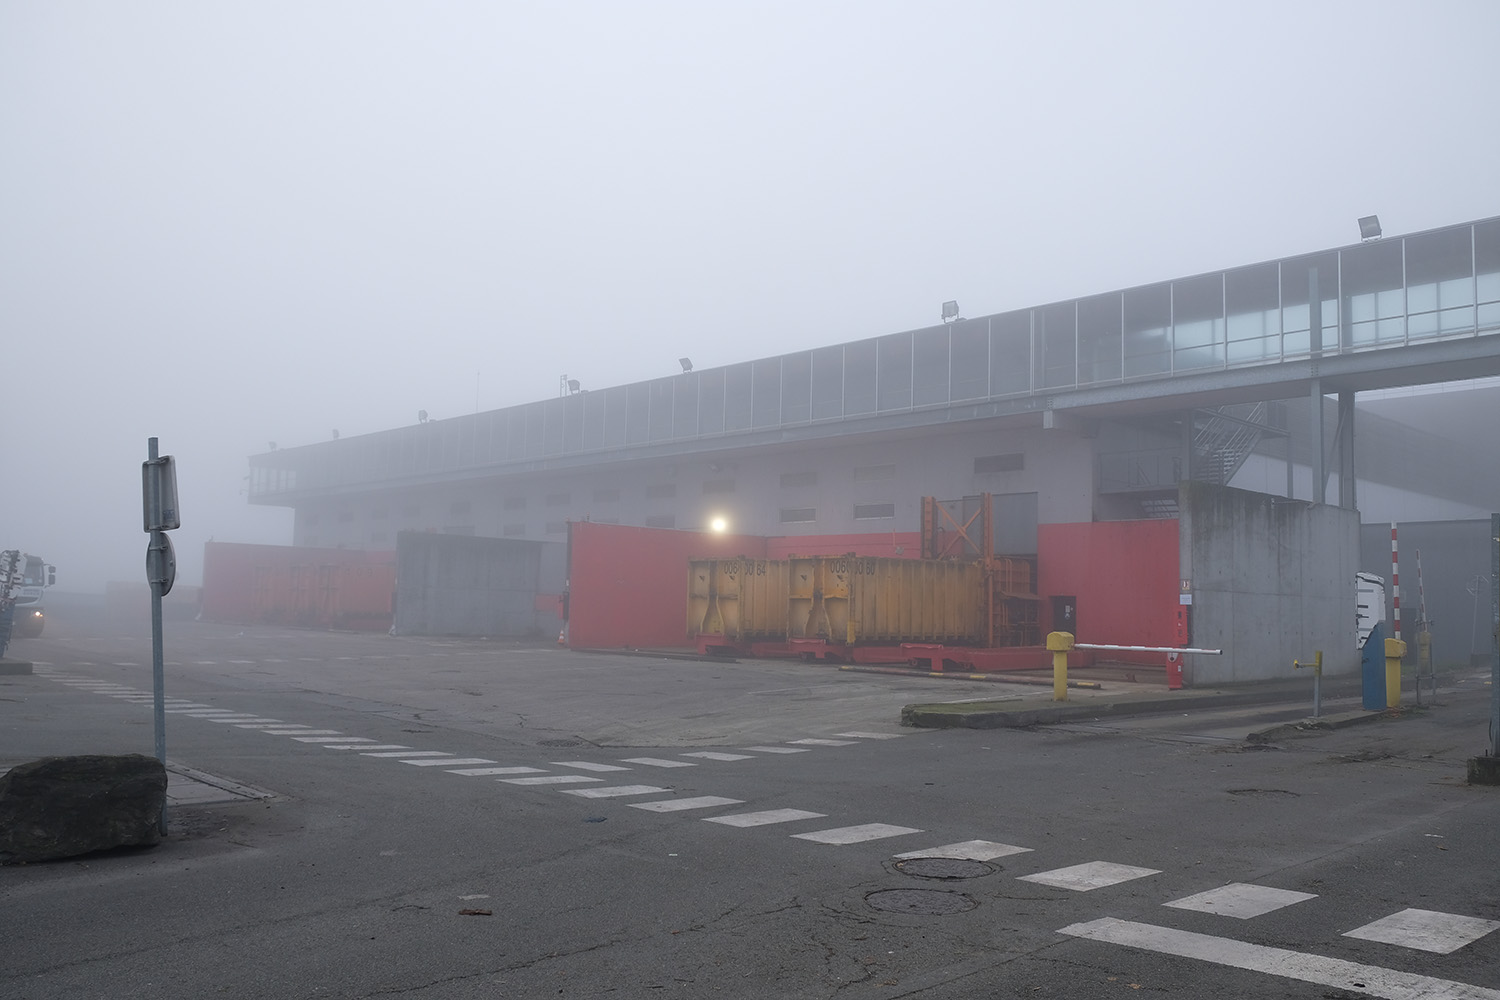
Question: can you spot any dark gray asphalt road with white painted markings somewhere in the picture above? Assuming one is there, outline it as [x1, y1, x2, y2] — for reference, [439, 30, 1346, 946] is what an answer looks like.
[0, 602, 1500, 1000]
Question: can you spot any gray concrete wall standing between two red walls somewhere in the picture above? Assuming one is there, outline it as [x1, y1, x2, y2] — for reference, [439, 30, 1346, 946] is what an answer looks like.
[393, 531, 564, 637]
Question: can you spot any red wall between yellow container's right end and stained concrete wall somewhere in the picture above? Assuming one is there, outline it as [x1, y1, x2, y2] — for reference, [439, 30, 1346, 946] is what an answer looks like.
[1037, 519, 1179, 663]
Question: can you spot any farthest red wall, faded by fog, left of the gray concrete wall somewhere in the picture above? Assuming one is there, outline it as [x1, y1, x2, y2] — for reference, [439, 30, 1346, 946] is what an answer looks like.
[201, 541, 396, 631]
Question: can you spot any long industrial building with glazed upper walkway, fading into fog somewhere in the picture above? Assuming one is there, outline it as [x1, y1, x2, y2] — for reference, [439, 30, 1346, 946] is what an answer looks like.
[251, 217, 1500, 679]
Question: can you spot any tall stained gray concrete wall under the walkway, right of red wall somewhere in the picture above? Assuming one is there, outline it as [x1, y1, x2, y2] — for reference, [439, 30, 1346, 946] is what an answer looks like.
[1178, 483, 1359, 691]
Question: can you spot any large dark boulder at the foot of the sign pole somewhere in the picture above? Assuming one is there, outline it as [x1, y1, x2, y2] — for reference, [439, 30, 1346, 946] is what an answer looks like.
[0, 754, 167, 862]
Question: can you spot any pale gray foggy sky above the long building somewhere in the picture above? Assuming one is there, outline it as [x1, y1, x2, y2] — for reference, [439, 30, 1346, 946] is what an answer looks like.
[0, 0, 1500, 589]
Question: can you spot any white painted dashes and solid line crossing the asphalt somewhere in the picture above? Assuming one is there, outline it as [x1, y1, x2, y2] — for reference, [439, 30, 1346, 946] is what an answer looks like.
[38, 659, 1500, 983]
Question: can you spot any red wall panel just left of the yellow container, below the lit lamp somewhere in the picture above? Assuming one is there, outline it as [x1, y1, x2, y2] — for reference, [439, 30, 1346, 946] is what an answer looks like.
[567, 520, 767, 649]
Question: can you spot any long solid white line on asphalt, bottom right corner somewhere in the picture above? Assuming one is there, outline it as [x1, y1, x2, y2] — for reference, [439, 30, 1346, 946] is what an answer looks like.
[1058, 916, 1500, 1000]
